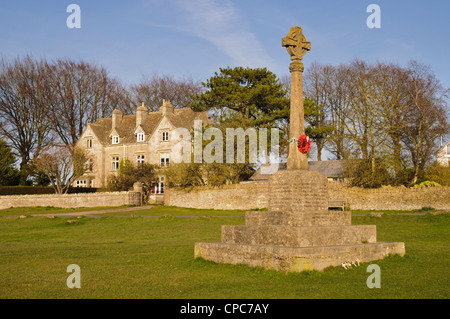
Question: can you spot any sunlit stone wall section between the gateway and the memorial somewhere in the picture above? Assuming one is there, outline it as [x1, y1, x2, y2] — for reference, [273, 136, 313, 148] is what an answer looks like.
[164, 182, 269, 210]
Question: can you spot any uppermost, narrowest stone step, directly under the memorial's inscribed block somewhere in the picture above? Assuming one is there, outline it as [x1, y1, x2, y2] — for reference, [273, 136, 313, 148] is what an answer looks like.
[245, 210, 352, 226]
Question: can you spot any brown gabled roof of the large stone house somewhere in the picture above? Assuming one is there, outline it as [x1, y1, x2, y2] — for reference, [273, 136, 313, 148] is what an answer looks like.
[89, 108, 211, 145]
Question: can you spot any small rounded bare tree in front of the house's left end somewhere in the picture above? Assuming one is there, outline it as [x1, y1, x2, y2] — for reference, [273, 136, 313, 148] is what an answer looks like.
[32, 145, 86, 194]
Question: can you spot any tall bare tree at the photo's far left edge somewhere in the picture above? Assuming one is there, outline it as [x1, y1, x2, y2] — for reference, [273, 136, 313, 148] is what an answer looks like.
[0, 55, 53, 183]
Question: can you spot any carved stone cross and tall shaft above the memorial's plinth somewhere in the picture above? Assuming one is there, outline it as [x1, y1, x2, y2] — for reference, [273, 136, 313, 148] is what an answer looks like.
[281, 26, 311, 169]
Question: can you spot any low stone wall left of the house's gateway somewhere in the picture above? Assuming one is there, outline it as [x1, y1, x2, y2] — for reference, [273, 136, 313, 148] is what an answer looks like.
[0, 192, 141, 209]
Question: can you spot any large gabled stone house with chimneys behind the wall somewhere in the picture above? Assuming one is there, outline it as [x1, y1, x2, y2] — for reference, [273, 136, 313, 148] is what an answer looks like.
[73, 101, 211, 193]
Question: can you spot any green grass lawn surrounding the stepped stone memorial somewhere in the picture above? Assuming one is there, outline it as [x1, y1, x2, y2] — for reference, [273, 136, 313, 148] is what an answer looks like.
[0, 207, 450, 299]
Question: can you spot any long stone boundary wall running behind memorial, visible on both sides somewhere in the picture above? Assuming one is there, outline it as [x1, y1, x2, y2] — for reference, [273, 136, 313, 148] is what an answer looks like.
[164, 181, 450, 210]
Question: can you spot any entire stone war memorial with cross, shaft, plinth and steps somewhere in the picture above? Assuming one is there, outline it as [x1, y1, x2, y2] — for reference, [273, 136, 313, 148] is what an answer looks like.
[195, 26, 405, 272]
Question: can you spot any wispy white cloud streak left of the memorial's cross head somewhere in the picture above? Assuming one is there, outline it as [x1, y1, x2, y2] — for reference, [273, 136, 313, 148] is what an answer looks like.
[176, 0, 273, 67]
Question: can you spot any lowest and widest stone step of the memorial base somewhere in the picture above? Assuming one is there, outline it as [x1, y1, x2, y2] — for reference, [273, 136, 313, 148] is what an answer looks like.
[195, 242, 405, 272]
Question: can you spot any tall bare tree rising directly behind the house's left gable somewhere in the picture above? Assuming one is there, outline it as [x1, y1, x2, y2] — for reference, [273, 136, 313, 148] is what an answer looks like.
[49, 59, 131, 145]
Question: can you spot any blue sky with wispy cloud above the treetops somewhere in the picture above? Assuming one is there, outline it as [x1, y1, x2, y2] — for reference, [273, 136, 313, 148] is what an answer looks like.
[0, 0, 450, 87]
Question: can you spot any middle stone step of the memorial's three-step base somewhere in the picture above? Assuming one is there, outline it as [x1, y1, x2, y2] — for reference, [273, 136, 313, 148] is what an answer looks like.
[222, 225, 377, 247]
